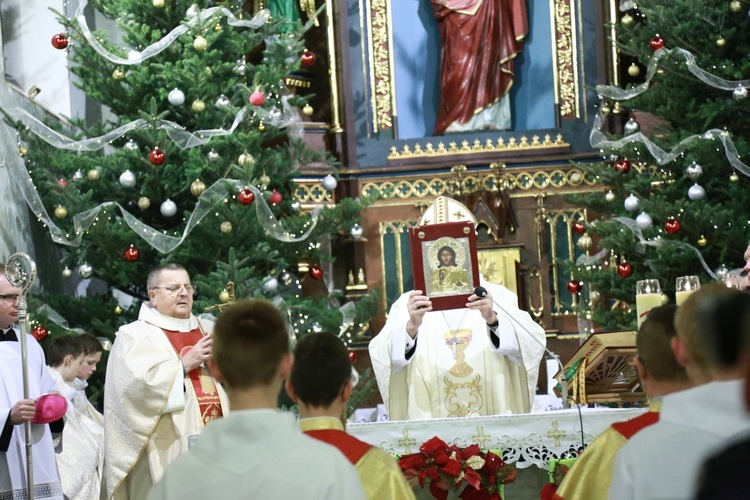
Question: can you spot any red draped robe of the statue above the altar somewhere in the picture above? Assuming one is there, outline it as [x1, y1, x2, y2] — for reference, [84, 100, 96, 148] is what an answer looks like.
[431, 0, 528, 135]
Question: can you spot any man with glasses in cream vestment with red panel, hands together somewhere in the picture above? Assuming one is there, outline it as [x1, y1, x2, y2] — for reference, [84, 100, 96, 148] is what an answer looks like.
[104, 264, 228, 499]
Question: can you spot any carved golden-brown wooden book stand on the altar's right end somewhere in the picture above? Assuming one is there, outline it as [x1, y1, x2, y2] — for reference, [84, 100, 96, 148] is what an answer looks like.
[555, 330, 647, 405]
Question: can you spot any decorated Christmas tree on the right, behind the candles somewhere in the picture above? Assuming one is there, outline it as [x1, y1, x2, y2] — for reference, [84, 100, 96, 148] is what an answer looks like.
[568, 0, 750, 328]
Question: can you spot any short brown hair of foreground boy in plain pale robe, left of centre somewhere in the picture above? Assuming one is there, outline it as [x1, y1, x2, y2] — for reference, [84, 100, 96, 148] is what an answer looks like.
[212, 299, 289, 389]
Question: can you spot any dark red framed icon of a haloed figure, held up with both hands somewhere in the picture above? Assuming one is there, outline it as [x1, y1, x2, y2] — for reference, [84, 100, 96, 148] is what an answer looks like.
[410, 222, 479, 311]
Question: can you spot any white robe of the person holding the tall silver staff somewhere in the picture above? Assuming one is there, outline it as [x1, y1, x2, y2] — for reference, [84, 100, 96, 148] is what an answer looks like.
[0, 330, 63, 500]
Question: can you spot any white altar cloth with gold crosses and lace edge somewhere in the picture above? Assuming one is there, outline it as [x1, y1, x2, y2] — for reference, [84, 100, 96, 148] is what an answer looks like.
[346, 408, 646, 469]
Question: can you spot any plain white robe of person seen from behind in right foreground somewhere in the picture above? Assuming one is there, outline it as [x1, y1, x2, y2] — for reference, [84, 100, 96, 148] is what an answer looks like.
[609, 380, 750, 500]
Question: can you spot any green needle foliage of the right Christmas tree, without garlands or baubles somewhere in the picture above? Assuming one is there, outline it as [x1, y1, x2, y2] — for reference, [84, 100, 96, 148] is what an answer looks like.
[570, 0, 750, 328]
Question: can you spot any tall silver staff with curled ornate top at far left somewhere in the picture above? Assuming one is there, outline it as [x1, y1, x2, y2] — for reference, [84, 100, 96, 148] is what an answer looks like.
[5, 252, 36, 500]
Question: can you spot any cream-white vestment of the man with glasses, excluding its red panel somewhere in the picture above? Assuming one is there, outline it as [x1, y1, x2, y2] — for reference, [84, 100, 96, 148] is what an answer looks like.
[104, 304, 229, 499]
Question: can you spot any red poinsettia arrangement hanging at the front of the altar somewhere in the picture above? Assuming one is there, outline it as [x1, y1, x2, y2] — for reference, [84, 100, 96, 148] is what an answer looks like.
[398, 437, 516, 500]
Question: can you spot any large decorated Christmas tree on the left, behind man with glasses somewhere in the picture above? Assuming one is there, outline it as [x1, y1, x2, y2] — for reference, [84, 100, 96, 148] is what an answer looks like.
[3, 0, 377, 390]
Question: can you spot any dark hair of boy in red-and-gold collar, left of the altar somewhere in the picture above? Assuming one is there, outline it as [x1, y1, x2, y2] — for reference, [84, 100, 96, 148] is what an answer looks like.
[290, 333, 352, 408]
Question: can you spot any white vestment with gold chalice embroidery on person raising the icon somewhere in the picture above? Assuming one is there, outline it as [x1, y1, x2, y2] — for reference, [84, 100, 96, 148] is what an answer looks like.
[369, 282, 546, 420]
